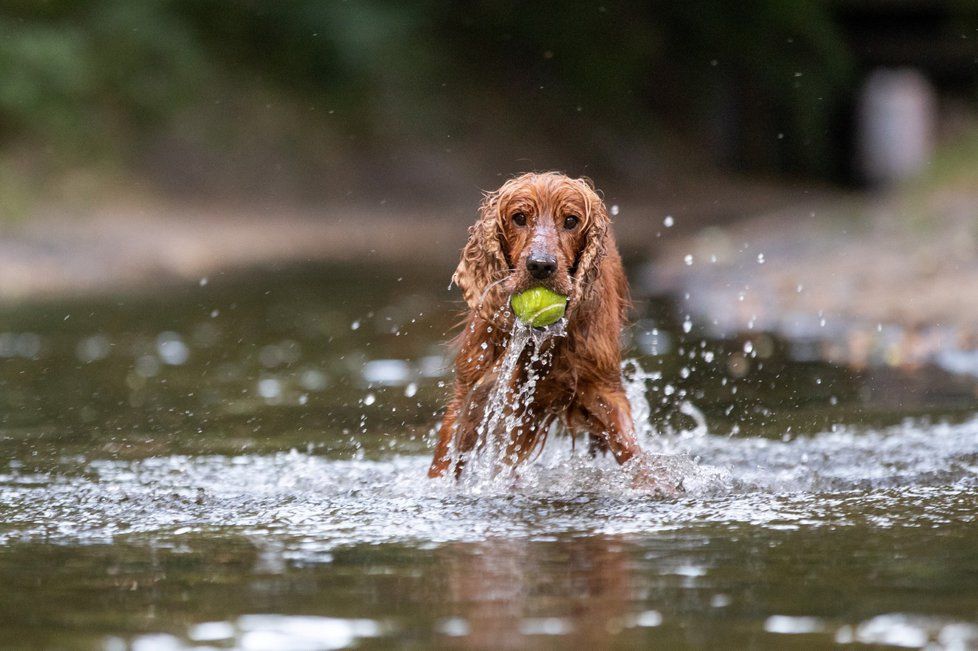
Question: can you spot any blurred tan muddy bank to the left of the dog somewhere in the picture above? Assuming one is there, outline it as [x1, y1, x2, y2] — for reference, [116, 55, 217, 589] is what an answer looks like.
[0, 206, 465, 303]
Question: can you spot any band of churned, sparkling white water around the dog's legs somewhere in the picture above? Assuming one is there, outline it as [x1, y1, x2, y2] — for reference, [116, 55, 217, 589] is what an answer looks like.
[0, 420, 978, 561]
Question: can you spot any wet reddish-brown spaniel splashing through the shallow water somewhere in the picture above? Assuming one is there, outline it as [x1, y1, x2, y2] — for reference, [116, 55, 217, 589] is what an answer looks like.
[428, 172, 641, 484]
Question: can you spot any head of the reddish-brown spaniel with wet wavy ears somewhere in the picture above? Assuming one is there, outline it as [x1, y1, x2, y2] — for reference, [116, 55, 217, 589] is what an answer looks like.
[453, 172, 609, 321]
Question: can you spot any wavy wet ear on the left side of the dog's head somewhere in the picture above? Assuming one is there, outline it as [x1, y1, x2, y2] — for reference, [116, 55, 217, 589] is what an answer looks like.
[452, 192, 509, 311]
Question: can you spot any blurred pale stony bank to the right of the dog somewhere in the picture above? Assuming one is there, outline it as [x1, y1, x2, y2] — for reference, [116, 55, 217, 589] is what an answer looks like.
[641, 188, 978, 372]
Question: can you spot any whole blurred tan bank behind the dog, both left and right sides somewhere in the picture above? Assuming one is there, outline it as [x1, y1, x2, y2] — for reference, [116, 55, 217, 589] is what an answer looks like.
[0, 176, 978, 374]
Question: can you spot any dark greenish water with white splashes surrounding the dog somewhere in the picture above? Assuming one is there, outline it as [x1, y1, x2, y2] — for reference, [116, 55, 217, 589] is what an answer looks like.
[0, 268, 978, 649]
